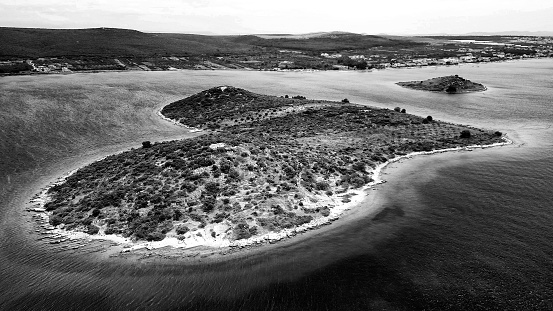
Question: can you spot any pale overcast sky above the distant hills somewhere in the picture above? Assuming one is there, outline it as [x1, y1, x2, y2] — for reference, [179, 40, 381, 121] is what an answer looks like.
[0, 0, 553, 35]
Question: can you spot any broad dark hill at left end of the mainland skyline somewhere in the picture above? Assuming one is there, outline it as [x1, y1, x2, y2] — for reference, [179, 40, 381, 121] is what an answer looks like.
[0, 28, 251, 57]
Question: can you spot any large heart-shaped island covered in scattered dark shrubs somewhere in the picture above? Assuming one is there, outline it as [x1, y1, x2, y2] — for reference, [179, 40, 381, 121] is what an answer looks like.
[38, 86, 505, 252]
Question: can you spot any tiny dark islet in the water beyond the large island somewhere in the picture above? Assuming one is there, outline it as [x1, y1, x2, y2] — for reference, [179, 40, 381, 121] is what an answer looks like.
[396, 75, 487, 94]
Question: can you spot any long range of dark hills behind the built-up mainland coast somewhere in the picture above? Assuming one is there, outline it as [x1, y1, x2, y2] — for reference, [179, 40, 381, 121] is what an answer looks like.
[0, 27, 417, 57]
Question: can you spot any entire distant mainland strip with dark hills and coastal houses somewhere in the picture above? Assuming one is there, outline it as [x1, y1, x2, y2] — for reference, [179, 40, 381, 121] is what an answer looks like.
[0, 27, 553, 76]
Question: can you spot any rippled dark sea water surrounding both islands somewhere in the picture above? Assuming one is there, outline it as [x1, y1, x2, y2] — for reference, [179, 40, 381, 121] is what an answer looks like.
[0, 60, 553, 310]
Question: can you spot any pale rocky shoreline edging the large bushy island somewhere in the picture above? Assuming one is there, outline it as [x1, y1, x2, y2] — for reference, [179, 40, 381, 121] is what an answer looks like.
[27, 125, 513, 258]
